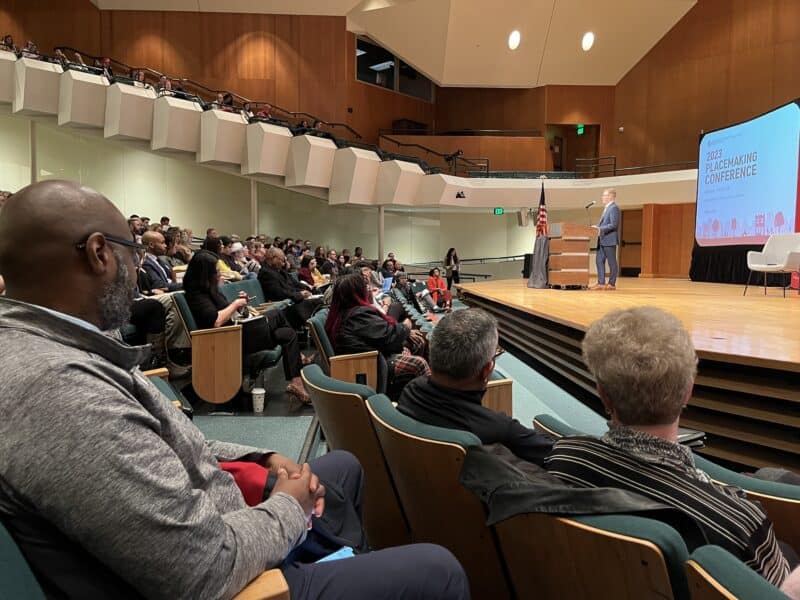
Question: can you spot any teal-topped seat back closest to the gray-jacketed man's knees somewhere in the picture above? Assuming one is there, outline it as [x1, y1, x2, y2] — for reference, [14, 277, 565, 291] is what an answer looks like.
[302, 365, 411, 548]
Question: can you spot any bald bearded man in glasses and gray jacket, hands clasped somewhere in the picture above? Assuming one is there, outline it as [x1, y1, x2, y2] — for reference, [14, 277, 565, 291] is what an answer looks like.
[0, 181, 468, 599]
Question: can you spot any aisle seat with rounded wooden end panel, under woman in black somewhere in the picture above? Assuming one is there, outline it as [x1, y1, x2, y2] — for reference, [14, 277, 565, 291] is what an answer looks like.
[172, 292, 281, 404]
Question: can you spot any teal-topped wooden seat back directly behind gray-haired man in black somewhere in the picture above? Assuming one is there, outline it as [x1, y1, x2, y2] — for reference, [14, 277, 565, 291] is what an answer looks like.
[367, 394, 510, 599]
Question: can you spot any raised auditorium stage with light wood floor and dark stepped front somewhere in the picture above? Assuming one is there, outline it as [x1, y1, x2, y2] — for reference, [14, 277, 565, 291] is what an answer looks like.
[458, 278, 800, 469]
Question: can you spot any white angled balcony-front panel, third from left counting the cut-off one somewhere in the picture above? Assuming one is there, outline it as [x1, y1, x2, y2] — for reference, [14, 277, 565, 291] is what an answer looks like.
[58, 70, 108, 127]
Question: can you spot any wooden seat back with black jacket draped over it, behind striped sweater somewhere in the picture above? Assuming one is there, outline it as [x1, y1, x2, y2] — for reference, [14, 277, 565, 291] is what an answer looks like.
[495, 513, 688, 600]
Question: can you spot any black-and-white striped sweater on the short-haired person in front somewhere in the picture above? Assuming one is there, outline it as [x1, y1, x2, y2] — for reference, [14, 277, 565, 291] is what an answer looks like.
[545, 425, 789, 585]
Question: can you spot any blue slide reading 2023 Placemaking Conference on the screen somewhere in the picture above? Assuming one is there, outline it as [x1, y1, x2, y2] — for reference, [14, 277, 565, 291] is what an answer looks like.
[695, 102, 800, 246]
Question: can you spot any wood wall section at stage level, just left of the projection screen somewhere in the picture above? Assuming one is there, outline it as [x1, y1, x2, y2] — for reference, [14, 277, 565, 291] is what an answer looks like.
[640, 204, 697, 278]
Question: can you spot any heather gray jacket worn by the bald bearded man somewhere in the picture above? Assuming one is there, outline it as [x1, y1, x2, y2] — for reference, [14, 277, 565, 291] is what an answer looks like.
[0, 298, 306, 598]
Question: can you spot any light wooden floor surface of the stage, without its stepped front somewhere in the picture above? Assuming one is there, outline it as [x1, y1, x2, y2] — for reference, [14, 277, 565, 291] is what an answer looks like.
[460, 277, 800, 372]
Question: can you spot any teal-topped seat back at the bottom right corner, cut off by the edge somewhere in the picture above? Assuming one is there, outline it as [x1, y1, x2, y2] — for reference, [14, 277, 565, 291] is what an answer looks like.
[686, 545, 787, 600]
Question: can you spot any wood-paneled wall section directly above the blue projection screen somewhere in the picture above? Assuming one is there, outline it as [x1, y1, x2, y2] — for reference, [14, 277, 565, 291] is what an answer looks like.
[612, 0, 800, 167]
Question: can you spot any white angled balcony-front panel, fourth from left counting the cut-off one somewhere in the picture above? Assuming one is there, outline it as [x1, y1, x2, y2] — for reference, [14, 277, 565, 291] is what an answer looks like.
[103, 83, 156, 142]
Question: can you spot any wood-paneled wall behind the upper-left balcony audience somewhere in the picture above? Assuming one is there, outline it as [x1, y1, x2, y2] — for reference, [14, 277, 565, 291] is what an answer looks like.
[0, 0, 434, 142]
